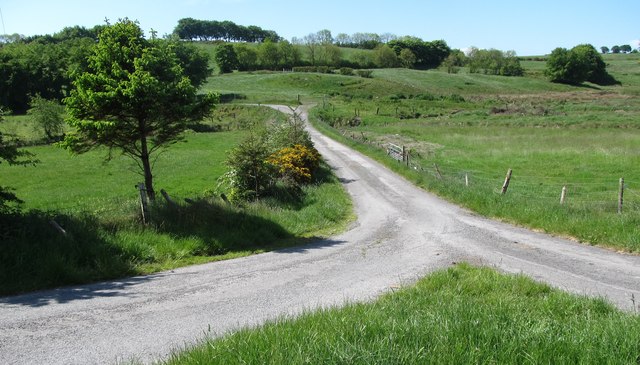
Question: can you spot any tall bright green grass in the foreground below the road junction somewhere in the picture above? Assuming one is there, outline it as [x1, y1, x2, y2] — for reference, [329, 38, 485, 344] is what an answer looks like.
[160, 264, 640, 364]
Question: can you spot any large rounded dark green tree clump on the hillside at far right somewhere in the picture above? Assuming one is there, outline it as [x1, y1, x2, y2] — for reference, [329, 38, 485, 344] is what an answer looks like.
[545, 44, 616, 85]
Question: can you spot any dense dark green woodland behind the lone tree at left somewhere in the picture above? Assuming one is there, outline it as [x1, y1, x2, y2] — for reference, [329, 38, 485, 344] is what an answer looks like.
[0, 26, 210, 114]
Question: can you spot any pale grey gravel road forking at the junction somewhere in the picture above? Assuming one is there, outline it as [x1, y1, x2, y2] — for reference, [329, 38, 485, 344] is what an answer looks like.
[0, 107, 640, 364]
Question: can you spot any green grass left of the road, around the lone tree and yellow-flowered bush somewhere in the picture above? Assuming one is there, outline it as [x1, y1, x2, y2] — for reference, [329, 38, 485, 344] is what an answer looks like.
[0, 106, 351, 295]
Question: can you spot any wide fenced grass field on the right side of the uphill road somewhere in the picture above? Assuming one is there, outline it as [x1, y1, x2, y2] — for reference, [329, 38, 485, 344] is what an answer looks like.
[199, 54, 640, 252]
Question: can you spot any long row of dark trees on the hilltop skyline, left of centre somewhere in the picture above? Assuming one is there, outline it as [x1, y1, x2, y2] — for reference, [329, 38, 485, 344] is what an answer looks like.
[173, 18, 281, 43]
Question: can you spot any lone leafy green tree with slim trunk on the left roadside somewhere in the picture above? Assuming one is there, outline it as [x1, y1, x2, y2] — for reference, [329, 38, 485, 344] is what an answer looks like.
[62, 19, 214, 199]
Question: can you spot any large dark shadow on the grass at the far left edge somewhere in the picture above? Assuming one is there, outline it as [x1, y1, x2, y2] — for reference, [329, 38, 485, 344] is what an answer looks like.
[0, 211, 136, 295]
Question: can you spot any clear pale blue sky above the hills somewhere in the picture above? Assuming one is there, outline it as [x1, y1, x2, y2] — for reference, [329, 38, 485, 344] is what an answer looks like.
[0, 0, 640, 56]
